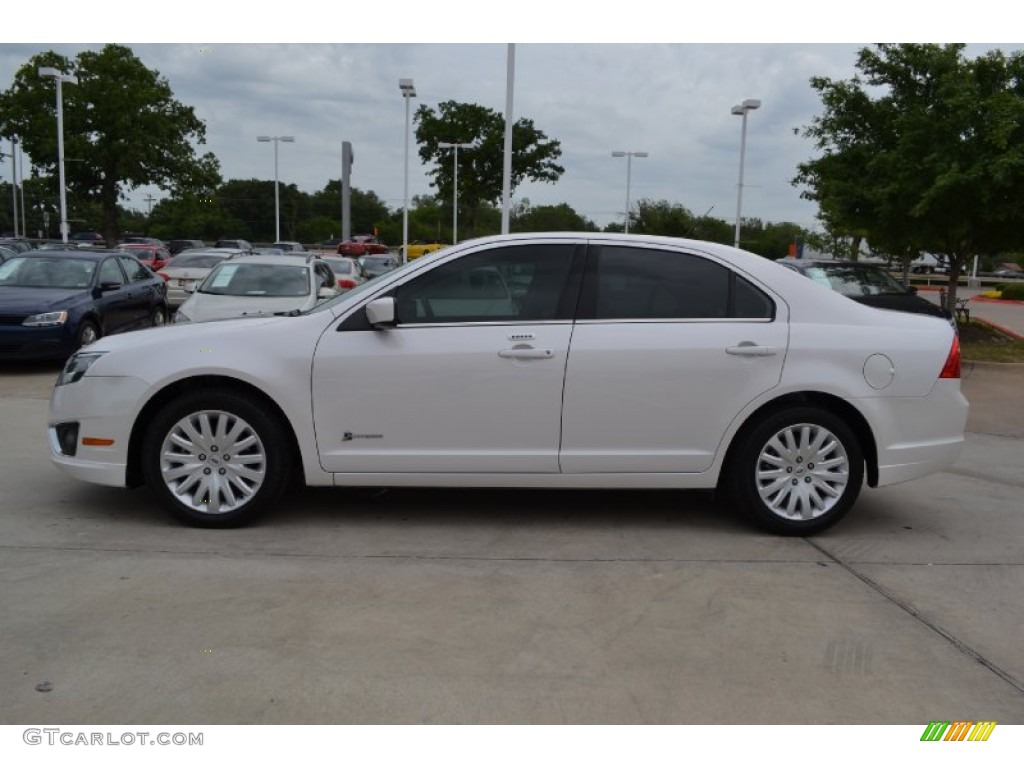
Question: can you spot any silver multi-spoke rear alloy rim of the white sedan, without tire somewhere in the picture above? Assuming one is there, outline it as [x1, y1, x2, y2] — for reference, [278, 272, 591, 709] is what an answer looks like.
[755, 424, 850, 520]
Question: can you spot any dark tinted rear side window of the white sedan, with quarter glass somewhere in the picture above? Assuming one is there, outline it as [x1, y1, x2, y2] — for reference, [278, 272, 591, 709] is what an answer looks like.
[589, 246, 774, 319]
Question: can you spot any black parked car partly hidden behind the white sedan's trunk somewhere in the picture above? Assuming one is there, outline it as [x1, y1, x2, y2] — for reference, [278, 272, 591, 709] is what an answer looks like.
[776, 259, 952, 321]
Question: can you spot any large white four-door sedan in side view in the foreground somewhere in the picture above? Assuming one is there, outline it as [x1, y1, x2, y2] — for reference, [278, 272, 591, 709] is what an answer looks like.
[48, 233, 968, 536]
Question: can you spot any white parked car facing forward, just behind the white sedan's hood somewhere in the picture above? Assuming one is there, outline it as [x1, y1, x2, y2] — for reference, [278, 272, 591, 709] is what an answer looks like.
[174, 255, 338, 323]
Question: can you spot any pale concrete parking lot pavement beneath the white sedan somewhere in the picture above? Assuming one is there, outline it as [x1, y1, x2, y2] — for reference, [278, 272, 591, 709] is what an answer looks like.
[0, 366, 1024, 724]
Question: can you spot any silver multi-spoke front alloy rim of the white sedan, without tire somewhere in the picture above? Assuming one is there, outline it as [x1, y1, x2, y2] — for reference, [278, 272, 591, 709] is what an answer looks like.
[160, 411, 267, 515]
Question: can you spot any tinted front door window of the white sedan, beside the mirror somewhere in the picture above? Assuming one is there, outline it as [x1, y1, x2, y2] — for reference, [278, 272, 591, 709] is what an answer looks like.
[395, 245, 572, 324]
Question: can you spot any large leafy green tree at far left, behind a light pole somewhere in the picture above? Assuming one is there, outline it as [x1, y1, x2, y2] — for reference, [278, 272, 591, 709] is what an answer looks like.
[0, 45, 219, 246]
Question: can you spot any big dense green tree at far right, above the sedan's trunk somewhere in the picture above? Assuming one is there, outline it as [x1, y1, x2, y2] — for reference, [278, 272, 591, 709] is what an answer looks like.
[794, 44, 1024, 302]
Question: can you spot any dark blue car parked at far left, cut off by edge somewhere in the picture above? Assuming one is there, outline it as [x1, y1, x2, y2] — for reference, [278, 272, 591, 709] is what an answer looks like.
[0, 251, 168, 359]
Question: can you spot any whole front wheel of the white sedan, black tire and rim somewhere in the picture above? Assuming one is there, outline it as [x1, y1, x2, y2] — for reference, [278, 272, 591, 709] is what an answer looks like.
[141, 389, 293, 528]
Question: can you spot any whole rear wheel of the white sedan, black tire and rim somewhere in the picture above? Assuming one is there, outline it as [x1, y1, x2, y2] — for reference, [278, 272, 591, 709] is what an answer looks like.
[726, 406, 864, 536]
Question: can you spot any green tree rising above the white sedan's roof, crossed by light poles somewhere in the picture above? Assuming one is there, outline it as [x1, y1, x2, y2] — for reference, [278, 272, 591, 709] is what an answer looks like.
[415, 101, 565, 237]
